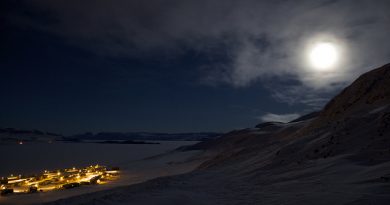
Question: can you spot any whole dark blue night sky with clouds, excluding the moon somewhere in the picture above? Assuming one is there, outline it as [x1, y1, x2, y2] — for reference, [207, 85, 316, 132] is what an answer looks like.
[0, 0, 390, 134]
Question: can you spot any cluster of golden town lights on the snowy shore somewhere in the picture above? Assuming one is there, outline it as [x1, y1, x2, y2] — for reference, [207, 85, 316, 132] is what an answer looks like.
[0, 165, 119, 195]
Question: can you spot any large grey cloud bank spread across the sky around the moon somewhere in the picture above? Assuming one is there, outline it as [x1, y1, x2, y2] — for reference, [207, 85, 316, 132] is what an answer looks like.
[8, 0, 390, 107]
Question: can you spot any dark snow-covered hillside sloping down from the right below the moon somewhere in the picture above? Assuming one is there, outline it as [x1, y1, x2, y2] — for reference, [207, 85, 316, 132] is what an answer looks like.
[12, 65, 390, 205]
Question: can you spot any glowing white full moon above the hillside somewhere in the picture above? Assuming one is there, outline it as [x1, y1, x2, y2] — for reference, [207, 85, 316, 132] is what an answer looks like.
[309, 42, 339, 71]
